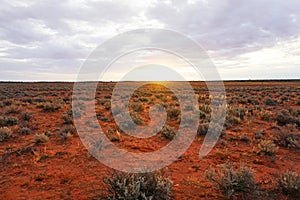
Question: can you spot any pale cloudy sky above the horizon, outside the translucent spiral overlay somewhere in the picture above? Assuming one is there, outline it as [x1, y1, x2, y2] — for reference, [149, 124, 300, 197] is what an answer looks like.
[0, 0, 300, 81]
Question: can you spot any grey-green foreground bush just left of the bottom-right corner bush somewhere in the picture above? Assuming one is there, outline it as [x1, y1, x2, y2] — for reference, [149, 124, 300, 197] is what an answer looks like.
[205, 163, 258, 198]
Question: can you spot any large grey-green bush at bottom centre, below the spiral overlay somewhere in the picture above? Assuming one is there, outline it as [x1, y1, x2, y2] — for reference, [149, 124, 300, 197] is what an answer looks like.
[100, 172, 173, 200]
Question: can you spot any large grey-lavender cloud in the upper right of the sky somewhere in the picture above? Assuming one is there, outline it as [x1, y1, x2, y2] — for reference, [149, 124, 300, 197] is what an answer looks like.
[147, 0, 300, 50]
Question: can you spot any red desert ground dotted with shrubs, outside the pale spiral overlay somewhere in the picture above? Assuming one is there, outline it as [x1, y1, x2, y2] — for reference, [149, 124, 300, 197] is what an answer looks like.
[0, 80, 300, 200]
